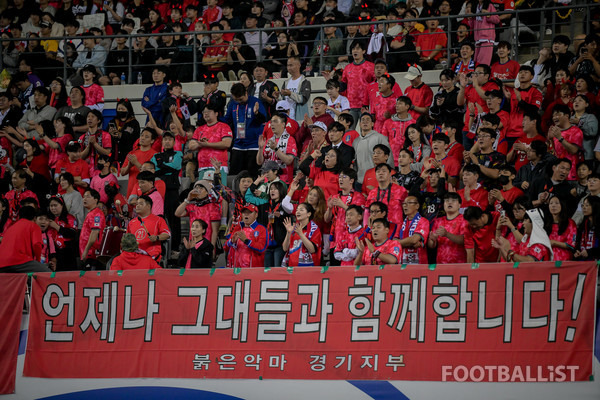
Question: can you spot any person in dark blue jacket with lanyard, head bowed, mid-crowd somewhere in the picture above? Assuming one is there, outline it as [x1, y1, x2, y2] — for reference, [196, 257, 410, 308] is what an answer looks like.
[221, 83, 267, 175]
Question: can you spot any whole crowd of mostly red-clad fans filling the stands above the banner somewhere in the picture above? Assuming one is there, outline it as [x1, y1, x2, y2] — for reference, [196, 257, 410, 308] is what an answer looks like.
[0, 0, 600, 272]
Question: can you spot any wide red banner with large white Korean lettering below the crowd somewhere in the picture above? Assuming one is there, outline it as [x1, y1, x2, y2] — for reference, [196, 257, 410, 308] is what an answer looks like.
[24, 262, 597, 382]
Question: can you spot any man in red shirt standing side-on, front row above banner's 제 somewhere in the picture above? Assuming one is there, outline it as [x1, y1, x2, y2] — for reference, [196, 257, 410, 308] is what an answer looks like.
[79, 189, 106, 270]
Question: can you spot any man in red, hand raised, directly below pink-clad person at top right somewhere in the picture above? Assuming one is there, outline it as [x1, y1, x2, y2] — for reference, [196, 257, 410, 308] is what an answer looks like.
[456, 64, 500, 150]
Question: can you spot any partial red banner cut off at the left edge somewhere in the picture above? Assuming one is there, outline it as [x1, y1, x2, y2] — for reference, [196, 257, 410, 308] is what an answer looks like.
[0, 274, 27, 394]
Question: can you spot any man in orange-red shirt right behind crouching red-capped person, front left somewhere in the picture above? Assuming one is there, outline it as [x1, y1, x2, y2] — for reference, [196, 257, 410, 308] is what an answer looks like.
[127, 195, 171, 261]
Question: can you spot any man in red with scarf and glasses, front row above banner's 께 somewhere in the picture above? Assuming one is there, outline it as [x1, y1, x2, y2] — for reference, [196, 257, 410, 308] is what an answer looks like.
[398, 196, 429, 264]
